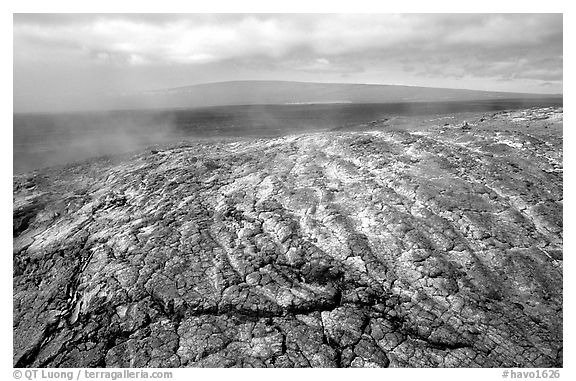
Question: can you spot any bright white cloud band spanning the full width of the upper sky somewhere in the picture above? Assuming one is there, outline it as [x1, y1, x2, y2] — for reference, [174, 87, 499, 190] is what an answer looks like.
[14, 14, 562, 64]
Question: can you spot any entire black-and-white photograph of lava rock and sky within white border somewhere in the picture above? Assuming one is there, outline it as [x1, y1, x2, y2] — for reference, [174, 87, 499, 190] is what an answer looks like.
[7, 8, 569, 372]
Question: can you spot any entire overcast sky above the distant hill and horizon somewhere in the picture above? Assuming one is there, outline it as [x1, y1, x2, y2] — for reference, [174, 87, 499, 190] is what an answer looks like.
[14, 14, 563, 111]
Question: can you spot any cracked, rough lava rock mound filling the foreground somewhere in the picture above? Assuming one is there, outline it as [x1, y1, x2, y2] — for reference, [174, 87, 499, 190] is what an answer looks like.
[13, 109, 563, 367]
